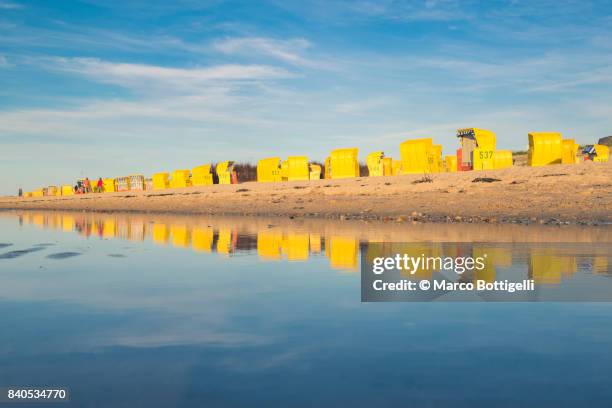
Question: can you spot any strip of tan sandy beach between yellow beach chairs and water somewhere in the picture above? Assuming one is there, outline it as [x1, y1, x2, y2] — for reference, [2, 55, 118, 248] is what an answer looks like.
[0, 162, 612, 225]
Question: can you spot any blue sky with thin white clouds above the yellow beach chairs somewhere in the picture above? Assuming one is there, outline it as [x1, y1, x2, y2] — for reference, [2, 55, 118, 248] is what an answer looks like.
[0, 0, 612, 194]
